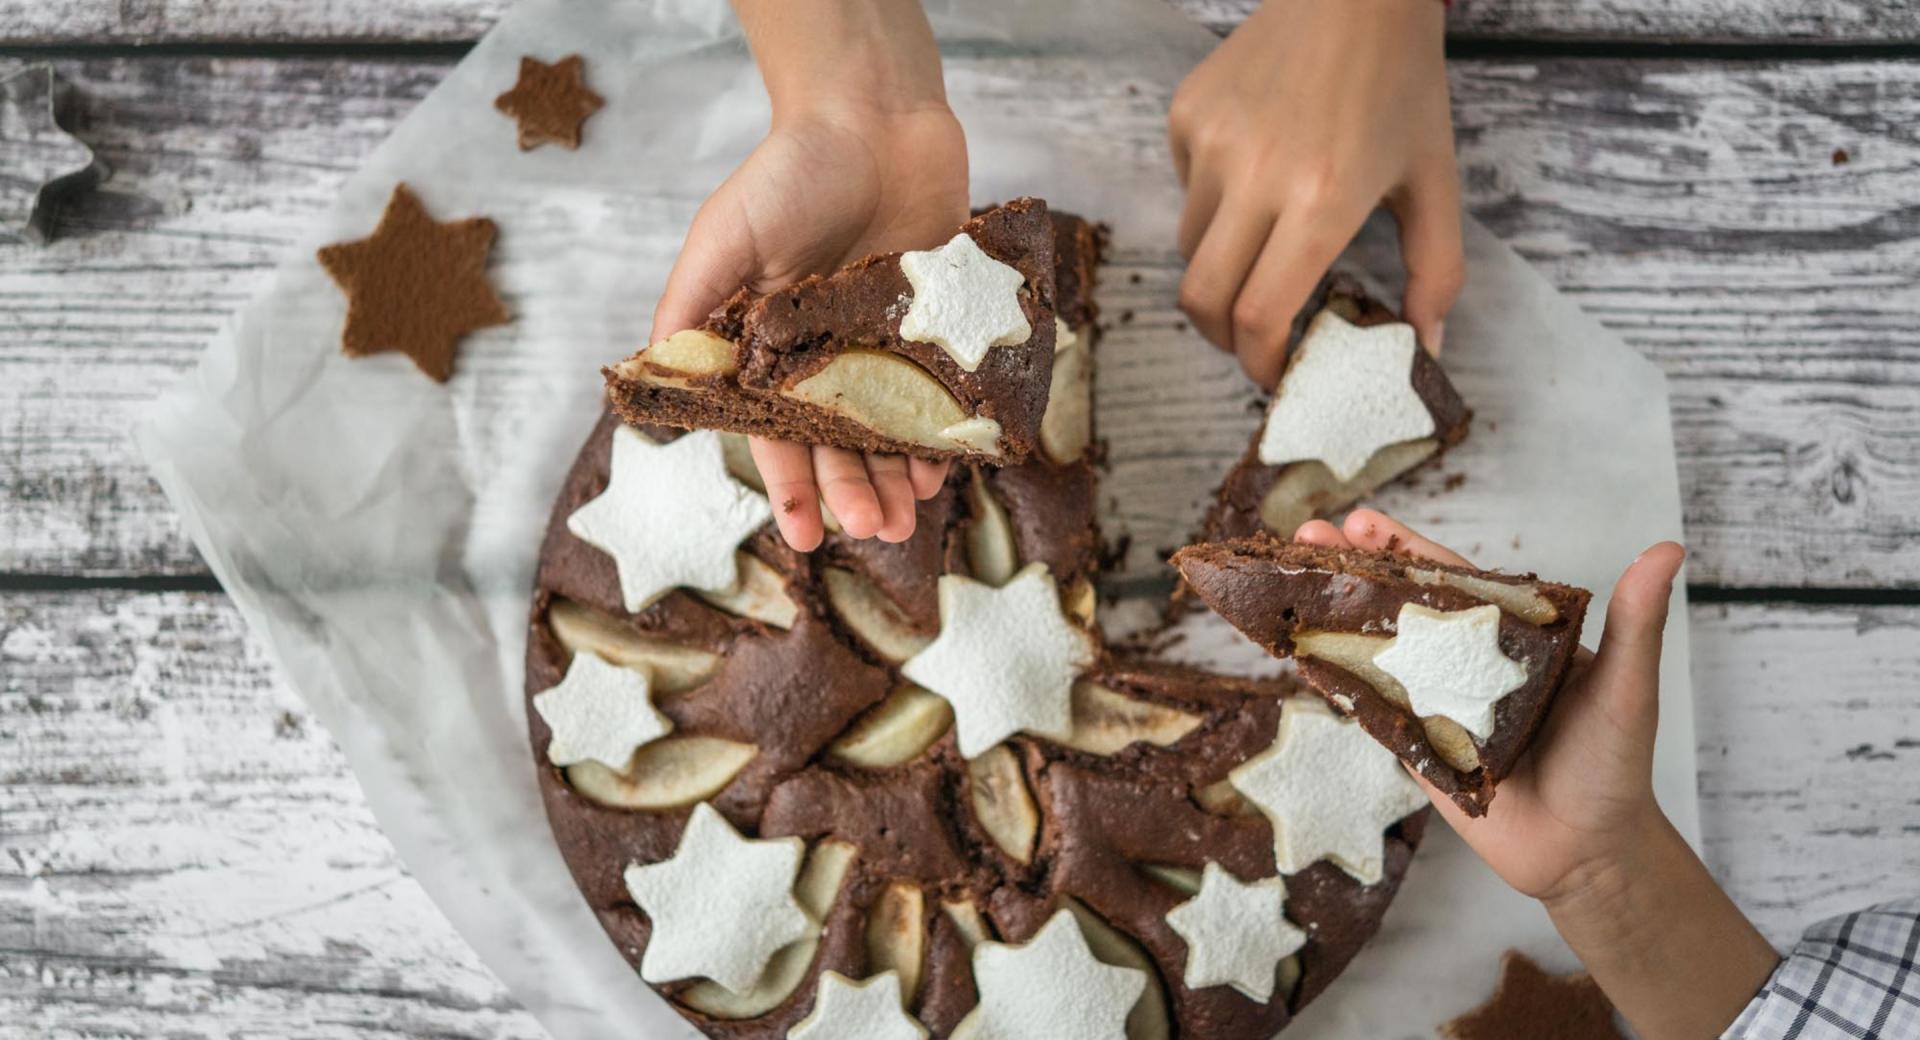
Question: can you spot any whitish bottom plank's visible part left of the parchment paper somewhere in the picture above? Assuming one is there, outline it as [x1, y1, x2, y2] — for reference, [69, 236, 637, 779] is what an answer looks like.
[0, 593, 543, 1040]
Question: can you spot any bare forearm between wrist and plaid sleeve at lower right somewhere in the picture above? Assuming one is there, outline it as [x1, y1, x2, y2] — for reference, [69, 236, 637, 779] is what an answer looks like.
[1546, 814, 1780, 1040]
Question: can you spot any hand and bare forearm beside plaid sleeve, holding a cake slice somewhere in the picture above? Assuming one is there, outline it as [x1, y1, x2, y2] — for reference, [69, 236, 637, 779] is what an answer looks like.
[1294, 508, 1778, 1040]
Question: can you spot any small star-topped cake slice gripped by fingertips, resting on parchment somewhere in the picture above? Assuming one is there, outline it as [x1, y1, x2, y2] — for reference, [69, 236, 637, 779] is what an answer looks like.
[1204, 272, 1473, 539]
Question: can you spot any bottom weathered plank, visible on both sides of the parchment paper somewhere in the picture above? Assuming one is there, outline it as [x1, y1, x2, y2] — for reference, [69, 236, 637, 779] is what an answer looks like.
[0, 593, 1920, 1038]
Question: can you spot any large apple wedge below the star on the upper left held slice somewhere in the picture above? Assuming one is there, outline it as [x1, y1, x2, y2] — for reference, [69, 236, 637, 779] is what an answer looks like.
[781, 349, 1000, 455]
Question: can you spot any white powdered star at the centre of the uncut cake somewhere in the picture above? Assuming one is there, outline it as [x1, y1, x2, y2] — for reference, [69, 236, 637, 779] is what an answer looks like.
[900, 562, 1094, 758]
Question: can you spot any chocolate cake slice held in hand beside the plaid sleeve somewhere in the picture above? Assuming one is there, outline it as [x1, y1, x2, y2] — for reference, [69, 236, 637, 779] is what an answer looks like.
[1173, 537, 1592, 815]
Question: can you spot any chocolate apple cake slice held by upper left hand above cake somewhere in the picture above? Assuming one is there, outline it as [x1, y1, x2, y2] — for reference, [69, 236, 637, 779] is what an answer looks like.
[605, 198, 1056, 464]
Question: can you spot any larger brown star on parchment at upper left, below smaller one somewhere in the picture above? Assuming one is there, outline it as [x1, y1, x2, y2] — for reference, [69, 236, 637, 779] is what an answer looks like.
[319, 184, 511, 382]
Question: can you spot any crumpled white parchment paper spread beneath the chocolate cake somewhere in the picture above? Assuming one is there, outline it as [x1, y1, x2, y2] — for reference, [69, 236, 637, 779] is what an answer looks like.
[138, 0, 1695, 1040]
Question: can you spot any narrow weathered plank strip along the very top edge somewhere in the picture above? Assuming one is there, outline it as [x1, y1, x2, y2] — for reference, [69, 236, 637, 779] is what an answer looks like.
[0, 0, 1920, 44]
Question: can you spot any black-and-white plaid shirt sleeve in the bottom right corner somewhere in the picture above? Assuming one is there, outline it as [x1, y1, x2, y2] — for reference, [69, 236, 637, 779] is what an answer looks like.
[1720, 898, 1920, 1040]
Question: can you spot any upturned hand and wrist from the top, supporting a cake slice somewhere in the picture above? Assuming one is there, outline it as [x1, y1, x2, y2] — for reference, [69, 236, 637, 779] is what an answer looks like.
[649, 0, 968, 551]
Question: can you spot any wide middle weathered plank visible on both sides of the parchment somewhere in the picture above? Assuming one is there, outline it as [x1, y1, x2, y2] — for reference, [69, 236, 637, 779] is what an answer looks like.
[0, 58, 1920, 587]
